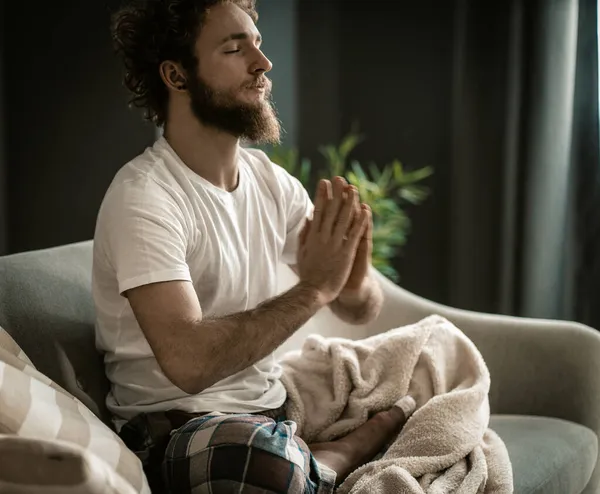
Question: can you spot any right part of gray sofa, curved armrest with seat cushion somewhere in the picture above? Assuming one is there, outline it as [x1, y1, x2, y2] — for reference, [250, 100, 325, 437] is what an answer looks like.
[280, 267, 600, 494]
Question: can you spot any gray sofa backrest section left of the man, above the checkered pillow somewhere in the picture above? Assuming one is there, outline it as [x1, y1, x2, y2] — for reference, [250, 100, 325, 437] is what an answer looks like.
[0, 241, 110, 423]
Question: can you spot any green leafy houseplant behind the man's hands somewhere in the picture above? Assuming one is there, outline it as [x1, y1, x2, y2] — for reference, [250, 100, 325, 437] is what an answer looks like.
[269, 131, 433, 281]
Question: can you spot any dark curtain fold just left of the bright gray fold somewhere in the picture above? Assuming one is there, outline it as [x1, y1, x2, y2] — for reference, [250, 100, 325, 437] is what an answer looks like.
[450, 0, 513, 312]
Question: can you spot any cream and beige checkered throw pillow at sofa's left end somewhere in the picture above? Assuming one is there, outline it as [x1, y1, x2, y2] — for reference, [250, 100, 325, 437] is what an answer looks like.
[0, 328, 150, 494]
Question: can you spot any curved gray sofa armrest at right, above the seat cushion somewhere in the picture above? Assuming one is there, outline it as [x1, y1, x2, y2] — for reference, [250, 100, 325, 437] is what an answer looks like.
[367, 273, 600, 436]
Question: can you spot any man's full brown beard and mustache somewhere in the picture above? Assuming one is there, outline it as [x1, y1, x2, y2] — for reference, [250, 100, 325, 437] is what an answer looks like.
[188, 71, 281, 144]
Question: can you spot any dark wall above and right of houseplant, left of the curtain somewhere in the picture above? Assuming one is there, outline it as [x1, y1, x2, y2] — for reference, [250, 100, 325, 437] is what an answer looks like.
[299, 0, 454, 301]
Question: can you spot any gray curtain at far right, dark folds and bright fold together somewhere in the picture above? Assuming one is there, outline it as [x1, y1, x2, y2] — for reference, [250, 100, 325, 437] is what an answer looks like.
[449, 0, 598, 322]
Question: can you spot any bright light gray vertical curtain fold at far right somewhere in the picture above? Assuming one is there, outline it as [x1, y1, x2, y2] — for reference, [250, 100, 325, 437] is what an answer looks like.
[520, 0, 579, 319]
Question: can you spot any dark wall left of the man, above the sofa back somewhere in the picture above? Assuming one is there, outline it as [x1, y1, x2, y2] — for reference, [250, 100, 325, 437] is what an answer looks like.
[3, 0, 154, 252]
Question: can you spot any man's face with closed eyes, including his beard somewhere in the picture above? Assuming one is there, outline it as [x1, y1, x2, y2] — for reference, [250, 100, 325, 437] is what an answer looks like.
[187, 4, 280, 143]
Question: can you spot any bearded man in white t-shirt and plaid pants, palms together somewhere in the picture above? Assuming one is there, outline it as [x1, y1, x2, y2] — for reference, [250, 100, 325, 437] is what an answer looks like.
[93, 0, 404, 493]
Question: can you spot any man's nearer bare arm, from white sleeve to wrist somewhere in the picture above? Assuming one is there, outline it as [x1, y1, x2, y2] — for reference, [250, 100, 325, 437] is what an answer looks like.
[127, 281, 323, 394]
